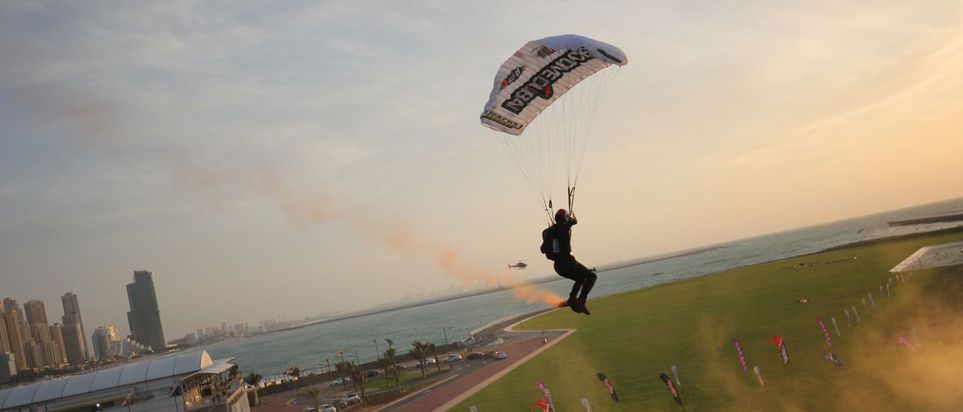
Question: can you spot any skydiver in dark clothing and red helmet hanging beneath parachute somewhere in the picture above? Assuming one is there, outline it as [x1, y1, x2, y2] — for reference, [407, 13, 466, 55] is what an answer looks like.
[542, 209, 598, 315]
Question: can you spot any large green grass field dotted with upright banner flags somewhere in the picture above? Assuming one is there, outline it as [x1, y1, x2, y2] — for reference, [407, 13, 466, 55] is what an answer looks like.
[451, 232, 963, 412]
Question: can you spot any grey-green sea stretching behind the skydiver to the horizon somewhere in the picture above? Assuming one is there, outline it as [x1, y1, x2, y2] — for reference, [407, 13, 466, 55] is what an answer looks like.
[194, 198, 963, 380]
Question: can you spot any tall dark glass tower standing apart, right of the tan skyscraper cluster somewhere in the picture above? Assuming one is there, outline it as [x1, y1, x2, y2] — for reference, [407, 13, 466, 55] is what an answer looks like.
[127, 270, 167, 352]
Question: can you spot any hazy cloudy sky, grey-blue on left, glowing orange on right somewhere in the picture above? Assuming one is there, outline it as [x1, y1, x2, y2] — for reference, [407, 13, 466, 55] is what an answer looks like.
[0, 0, 963, 339]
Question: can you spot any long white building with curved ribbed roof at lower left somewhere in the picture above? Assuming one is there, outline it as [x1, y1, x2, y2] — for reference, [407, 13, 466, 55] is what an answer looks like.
[0, 351, 250, 412]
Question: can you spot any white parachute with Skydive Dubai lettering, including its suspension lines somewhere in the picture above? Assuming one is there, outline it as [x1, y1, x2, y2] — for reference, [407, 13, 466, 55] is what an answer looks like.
[481, 34, 628, 220]
